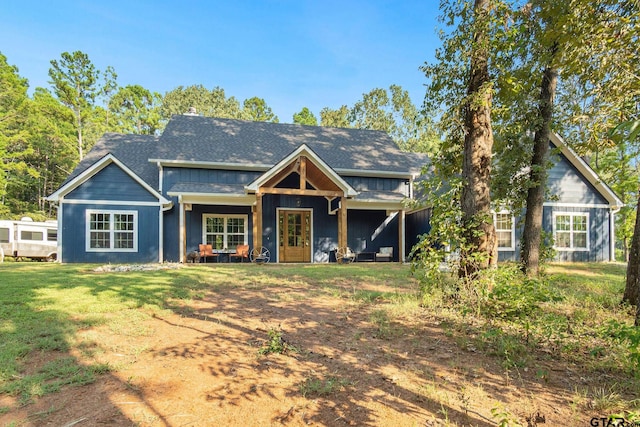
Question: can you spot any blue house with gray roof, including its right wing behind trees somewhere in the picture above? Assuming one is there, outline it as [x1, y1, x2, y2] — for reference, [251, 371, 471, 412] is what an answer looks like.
[48, 114, 621, 263]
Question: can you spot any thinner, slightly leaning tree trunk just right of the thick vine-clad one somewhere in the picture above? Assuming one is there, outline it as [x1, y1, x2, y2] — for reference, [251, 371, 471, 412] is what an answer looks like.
[522, 62, 558, 276]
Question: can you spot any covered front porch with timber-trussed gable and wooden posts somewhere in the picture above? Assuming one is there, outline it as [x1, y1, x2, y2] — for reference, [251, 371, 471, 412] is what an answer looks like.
[169, 145, 405, 263]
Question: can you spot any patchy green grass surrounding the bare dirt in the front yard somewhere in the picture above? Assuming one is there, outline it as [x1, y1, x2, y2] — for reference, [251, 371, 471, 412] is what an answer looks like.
[0, 263, 640, 422]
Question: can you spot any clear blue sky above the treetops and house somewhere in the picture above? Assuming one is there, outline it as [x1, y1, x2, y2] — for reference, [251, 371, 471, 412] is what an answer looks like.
[0, 0, 439, 123]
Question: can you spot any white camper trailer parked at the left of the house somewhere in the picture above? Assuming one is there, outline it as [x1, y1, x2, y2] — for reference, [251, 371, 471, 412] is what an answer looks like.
[0, 217, 58, 261]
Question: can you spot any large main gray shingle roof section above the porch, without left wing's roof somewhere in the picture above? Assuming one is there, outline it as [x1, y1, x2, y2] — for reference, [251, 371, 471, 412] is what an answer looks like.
[158, 115, 426, 172]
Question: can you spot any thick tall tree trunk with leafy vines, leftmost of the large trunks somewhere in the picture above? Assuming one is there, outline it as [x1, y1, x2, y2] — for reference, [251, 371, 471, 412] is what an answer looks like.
[458, 0, 497, 277]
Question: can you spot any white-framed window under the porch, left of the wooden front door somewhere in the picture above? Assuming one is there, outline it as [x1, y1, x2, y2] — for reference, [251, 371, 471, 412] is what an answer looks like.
[202, 214, 249, 249]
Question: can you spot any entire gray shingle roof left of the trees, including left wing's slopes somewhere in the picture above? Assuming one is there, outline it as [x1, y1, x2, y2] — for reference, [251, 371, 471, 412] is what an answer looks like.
[63, 115, 427, 192]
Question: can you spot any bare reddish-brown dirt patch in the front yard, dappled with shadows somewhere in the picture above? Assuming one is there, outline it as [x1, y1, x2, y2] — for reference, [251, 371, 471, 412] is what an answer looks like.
[0, 266, 624, 427]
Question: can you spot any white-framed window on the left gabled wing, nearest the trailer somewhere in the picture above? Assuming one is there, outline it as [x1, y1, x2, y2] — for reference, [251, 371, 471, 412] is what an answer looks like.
[86, 210, 138, 252]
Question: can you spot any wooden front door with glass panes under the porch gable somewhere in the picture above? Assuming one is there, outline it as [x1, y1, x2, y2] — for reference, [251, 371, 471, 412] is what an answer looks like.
[278, 210, 311, 262]
